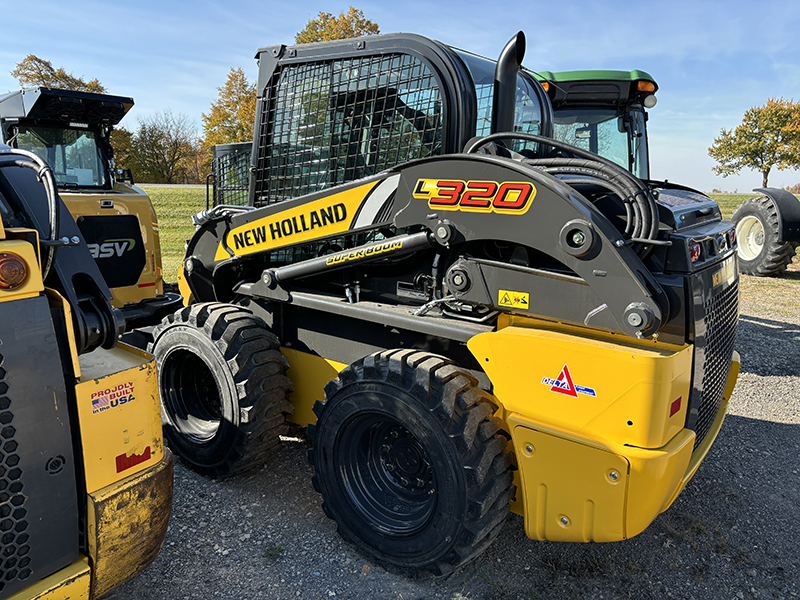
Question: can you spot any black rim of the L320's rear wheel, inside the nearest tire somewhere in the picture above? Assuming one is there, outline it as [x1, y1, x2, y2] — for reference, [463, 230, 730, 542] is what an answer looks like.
[336, 415, 437, 537]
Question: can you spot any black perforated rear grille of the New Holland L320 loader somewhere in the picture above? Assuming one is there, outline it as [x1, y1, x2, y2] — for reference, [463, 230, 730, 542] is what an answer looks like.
[695, 280, 739, 448]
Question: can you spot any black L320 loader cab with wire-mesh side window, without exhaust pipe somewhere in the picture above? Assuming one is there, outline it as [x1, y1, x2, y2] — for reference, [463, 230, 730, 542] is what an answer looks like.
[250, 34, 552, 206]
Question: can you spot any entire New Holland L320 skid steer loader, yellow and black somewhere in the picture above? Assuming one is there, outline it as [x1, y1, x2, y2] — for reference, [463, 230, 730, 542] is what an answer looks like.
[152, 34, 739, 573]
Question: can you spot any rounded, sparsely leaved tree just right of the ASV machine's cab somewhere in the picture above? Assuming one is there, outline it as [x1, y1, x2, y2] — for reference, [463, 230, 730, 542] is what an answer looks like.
[131, 110, 200, 183]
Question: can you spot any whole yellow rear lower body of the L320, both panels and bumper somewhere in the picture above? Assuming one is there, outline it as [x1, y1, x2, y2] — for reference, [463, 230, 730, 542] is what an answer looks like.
[467, 317, 739, 542]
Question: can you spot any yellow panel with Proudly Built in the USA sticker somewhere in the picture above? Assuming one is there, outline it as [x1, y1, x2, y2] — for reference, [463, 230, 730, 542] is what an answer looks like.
[76, 343, 164, 492]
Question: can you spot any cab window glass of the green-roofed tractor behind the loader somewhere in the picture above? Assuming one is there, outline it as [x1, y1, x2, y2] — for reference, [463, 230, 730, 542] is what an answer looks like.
[554, 107, 648, 179]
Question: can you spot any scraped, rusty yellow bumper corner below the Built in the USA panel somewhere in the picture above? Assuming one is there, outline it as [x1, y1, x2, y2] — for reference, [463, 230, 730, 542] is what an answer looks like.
[87, 450, 173, 597]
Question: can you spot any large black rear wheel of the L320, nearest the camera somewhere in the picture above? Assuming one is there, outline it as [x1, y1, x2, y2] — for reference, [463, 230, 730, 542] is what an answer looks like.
[309, 350, 515, 575]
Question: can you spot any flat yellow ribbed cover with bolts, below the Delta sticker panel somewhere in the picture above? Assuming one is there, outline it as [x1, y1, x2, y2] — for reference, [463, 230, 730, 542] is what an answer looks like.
[512, 425, 628, 542]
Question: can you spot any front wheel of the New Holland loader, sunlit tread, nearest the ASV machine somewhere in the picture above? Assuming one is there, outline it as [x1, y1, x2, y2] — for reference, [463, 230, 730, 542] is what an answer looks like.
[149, 303, 293, 476]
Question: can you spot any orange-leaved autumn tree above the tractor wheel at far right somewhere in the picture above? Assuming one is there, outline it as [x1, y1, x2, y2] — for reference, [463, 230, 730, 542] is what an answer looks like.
[708, 98, 800, 187]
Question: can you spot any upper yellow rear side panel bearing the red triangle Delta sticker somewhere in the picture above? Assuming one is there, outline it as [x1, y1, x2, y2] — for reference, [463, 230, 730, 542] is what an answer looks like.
[468, 324, 692, 448]
